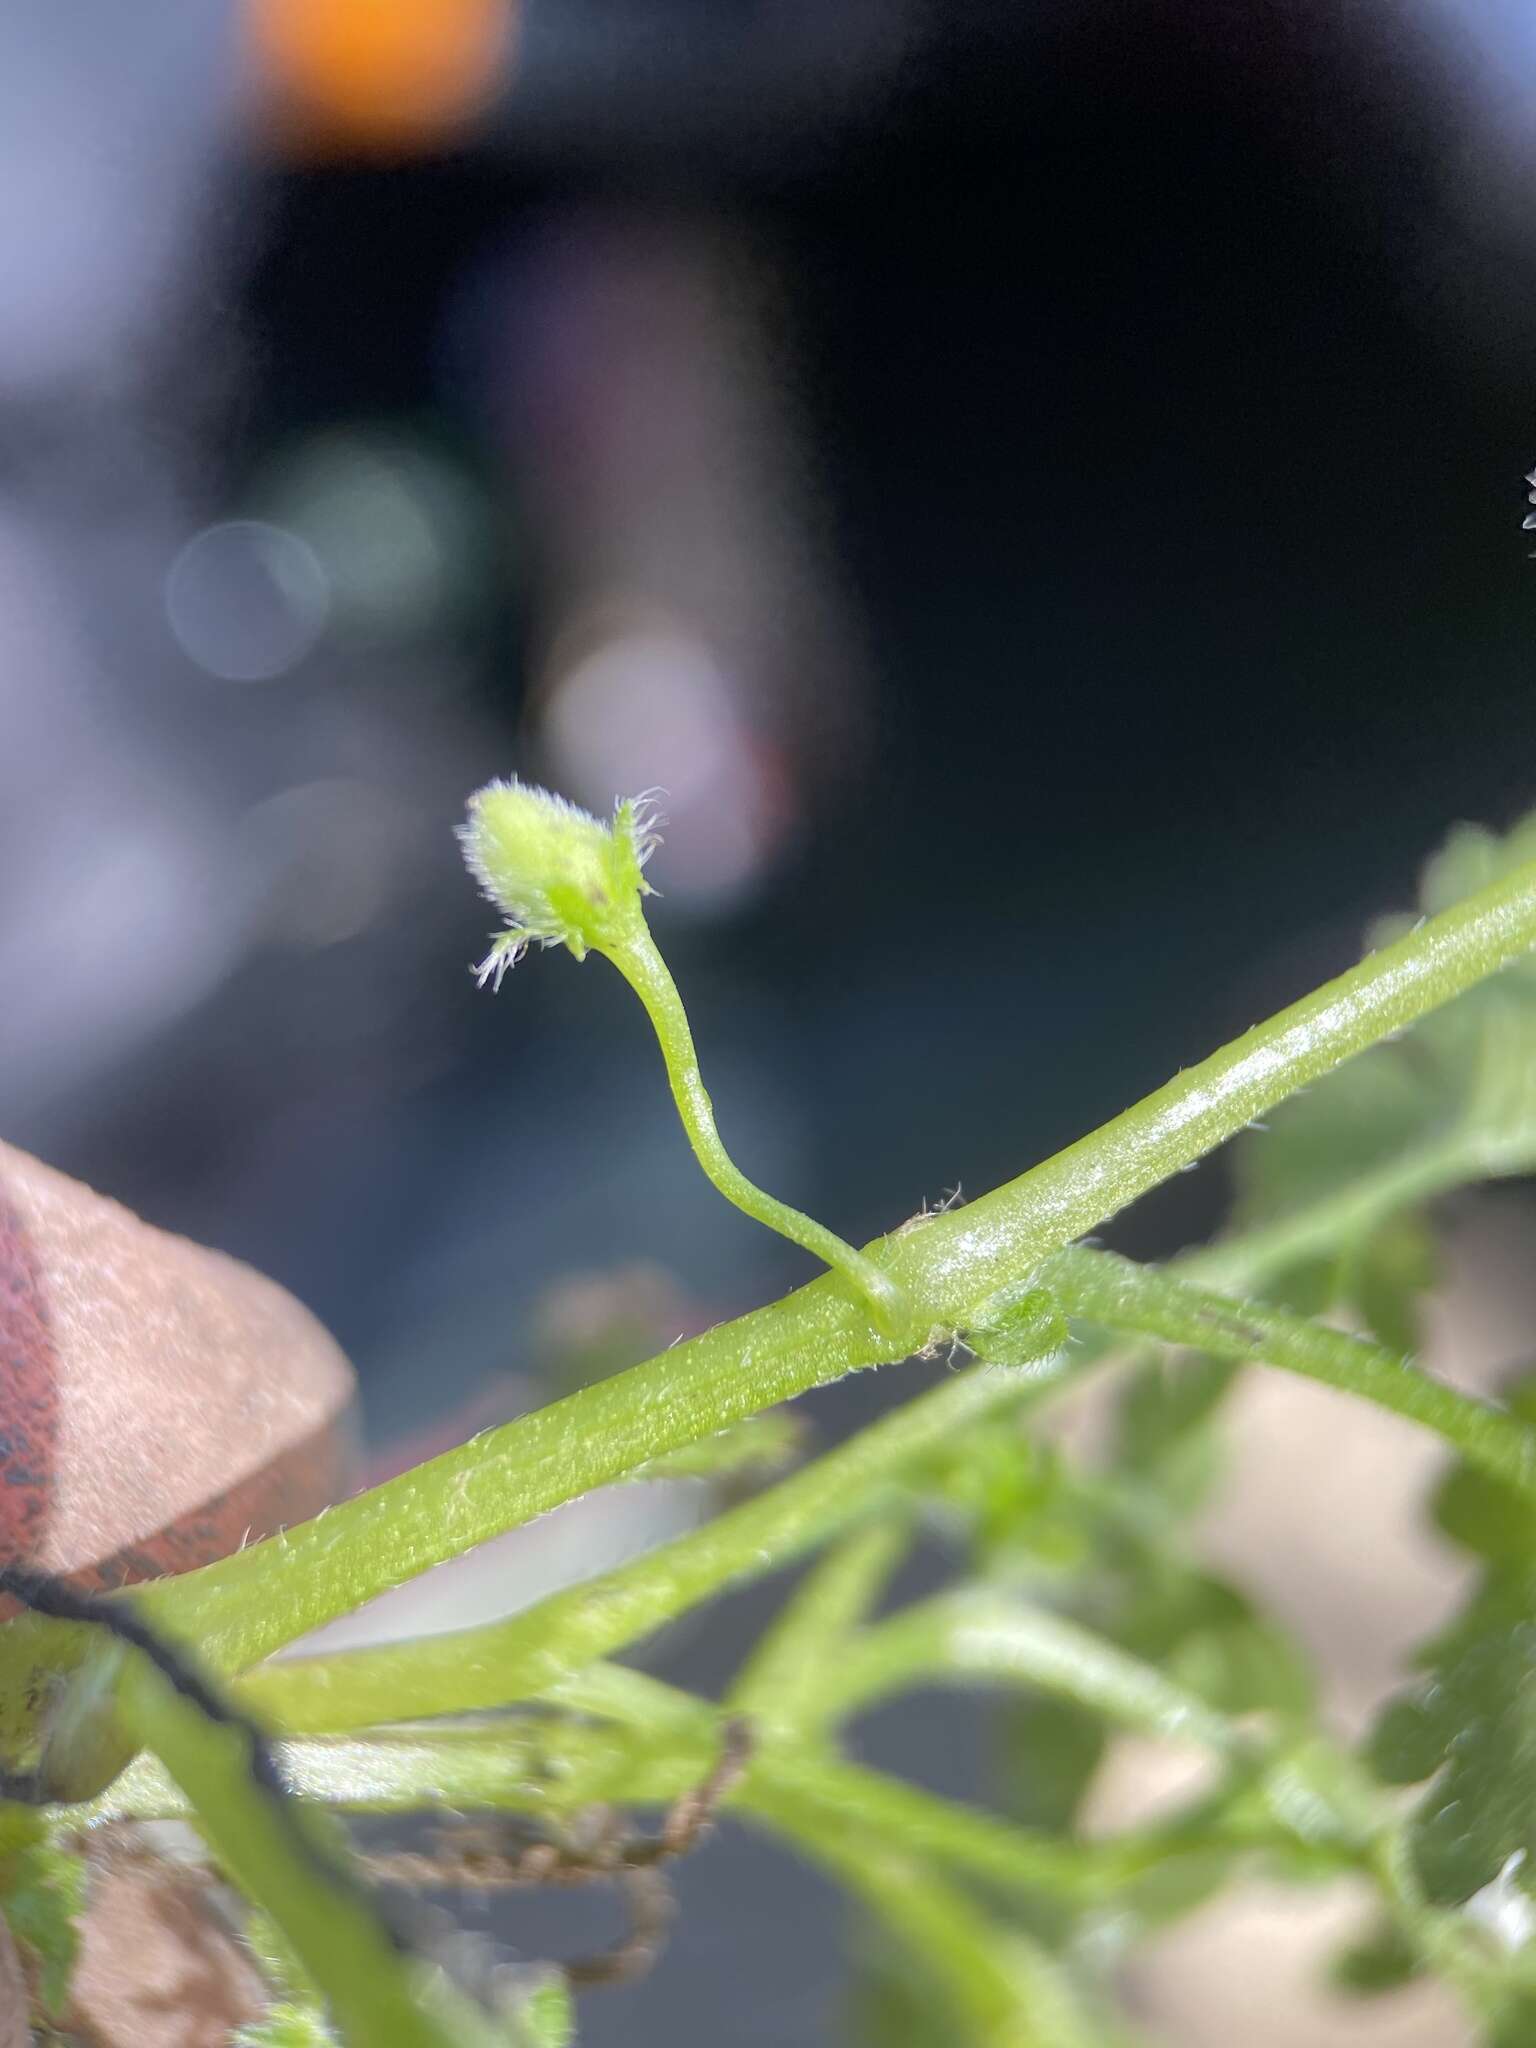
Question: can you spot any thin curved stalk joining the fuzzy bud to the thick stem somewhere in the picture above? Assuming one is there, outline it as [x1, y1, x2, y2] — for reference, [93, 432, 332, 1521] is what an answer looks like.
[604, 933, 922, 1341]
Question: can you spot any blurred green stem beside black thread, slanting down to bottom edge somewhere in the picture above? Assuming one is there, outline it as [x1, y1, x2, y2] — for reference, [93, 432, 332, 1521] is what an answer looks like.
[117, 1657, 494, 2048]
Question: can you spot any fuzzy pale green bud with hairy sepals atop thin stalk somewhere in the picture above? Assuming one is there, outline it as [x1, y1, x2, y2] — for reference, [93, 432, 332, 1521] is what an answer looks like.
[459, 776, 657, 989]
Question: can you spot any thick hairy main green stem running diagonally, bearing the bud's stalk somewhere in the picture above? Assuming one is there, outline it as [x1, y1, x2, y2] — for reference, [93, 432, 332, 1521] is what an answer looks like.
[48, 847, 1536, 1695]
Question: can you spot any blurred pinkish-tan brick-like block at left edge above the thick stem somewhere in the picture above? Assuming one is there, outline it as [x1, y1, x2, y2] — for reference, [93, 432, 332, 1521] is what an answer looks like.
[0, 1145, 354, 1585]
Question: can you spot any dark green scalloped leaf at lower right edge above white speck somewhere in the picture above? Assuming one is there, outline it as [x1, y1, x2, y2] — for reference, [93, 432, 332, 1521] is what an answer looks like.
[1370, 1567, 1536, 1905]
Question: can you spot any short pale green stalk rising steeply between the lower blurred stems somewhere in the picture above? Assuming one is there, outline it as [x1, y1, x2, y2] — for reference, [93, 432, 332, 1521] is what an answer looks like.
[727, 1513, 909, 1741]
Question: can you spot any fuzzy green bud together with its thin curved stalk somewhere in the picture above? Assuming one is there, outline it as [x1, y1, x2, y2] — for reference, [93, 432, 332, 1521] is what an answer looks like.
[459, 776, 909, 1337]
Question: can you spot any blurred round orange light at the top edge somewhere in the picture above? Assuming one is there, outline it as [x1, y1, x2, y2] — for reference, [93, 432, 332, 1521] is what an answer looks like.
[246, 0, 516, 156]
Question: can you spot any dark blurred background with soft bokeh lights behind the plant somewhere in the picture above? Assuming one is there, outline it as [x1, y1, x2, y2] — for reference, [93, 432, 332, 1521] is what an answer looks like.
[0, 0, 1536, 2042]
